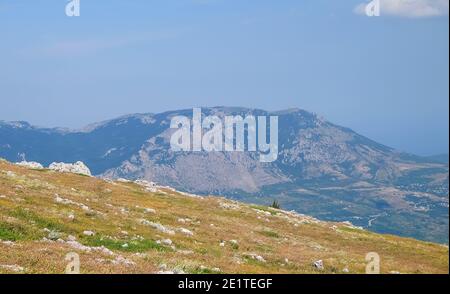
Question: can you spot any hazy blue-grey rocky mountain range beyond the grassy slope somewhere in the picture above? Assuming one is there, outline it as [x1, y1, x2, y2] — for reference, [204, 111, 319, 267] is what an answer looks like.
[0, 107, 449, 243]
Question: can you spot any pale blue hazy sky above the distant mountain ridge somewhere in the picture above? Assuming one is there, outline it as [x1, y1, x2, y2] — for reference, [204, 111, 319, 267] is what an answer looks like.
[0, 0, 449, 155]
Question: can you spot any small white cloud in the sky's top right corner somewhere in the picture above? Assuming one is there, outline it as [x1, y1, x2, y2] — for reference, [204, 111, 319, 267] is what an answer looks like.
[354, 0, 449, 18]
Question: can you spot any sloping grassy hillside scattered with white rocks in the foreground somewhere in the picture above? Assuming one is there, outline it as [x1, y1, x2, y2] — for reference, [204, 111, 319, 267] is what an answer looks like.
[0, 161, 449, 273]
